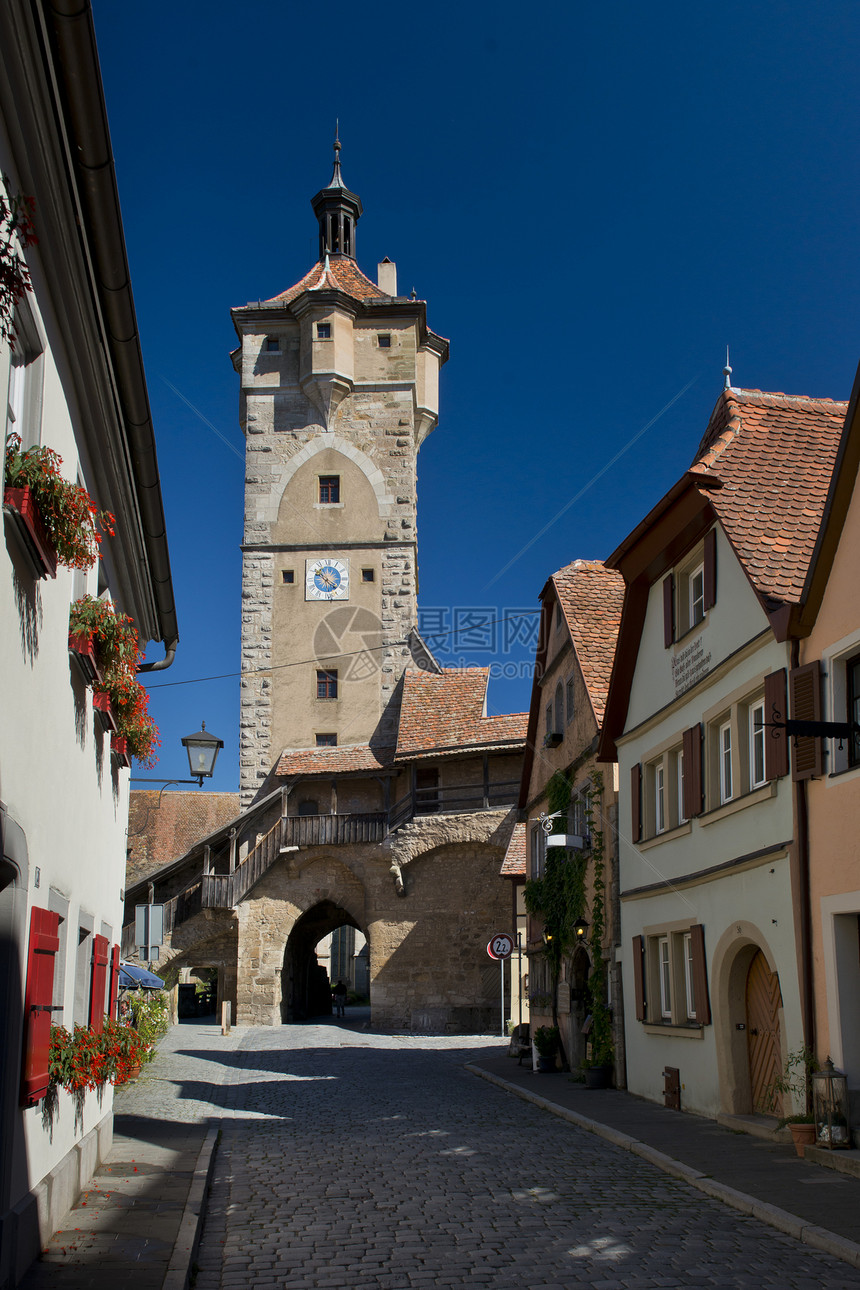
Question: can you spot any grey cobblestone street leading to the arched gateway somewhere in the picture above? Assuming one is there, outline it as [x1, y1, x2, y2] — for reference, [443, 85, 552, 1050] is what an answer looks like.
[196, 1026, 860, 1290]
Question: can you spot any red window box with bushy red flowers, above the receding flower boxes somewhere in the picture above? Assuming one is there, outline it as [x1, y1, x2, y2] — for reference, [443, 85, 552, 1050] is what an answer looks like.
[3, 435, 115, 578]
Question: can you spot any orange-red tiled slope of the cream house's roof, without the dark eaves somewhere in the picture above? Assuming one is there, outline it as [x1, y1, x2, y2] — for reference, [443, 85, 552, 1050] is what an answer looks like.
[691, 388, 848, 602]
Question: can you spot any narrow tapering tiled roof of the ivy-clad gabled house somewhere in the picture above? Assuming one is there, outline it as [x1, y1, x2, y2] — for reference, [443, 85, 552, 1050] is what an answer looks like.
[551, 560, 624, 725]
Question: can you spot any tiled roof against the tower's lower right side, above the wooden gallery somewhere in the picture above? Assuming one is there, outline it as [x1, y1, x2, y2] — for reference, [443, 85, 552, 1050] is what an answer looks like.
[396, 667, 529, 761]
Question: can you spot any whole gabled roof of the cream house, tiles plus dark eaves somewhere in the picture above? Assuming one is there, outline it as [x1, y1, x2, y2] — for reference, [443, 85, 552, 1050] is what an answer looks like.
[600, 388, 847, 761]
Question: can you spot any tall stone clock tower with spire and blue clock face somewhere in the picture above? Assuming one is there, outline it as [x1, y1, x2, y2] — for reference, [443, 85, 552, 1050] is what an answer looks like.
[232, 139, 447, 806]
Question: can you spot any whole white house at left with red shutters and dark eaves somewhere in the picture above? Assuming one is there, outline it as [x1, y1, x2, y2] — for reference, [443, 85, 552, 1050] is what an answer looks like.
[0, 0, 177, 1286]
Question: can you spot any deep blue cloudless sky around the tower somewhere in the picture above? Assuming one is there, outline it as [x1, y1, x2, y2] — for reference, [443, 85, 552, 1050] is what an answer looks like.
[88, 0, 860, 789]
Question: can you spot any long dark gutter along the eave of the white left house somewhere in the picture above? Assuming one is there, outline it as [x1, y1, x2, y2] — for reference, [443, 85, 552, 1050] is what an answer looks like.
[43, 0, 179, 672]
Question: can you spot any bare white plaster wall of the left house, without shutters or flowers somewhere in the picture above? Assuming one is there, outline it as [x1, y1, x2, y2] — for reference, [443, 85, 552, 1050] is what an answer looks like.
[0, 264, 129, 1196]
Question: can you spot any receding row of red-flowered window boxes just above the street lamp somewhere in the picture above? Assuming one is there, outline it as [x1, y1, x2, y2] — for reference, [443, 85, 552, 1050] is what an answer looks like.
[68, 596, 160, 766]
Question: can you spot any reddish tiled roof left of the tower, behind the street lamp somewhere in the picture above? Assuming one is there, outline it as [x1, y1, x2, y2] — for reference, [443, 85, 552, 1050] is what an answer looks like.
[125, 788, 240, 888]
